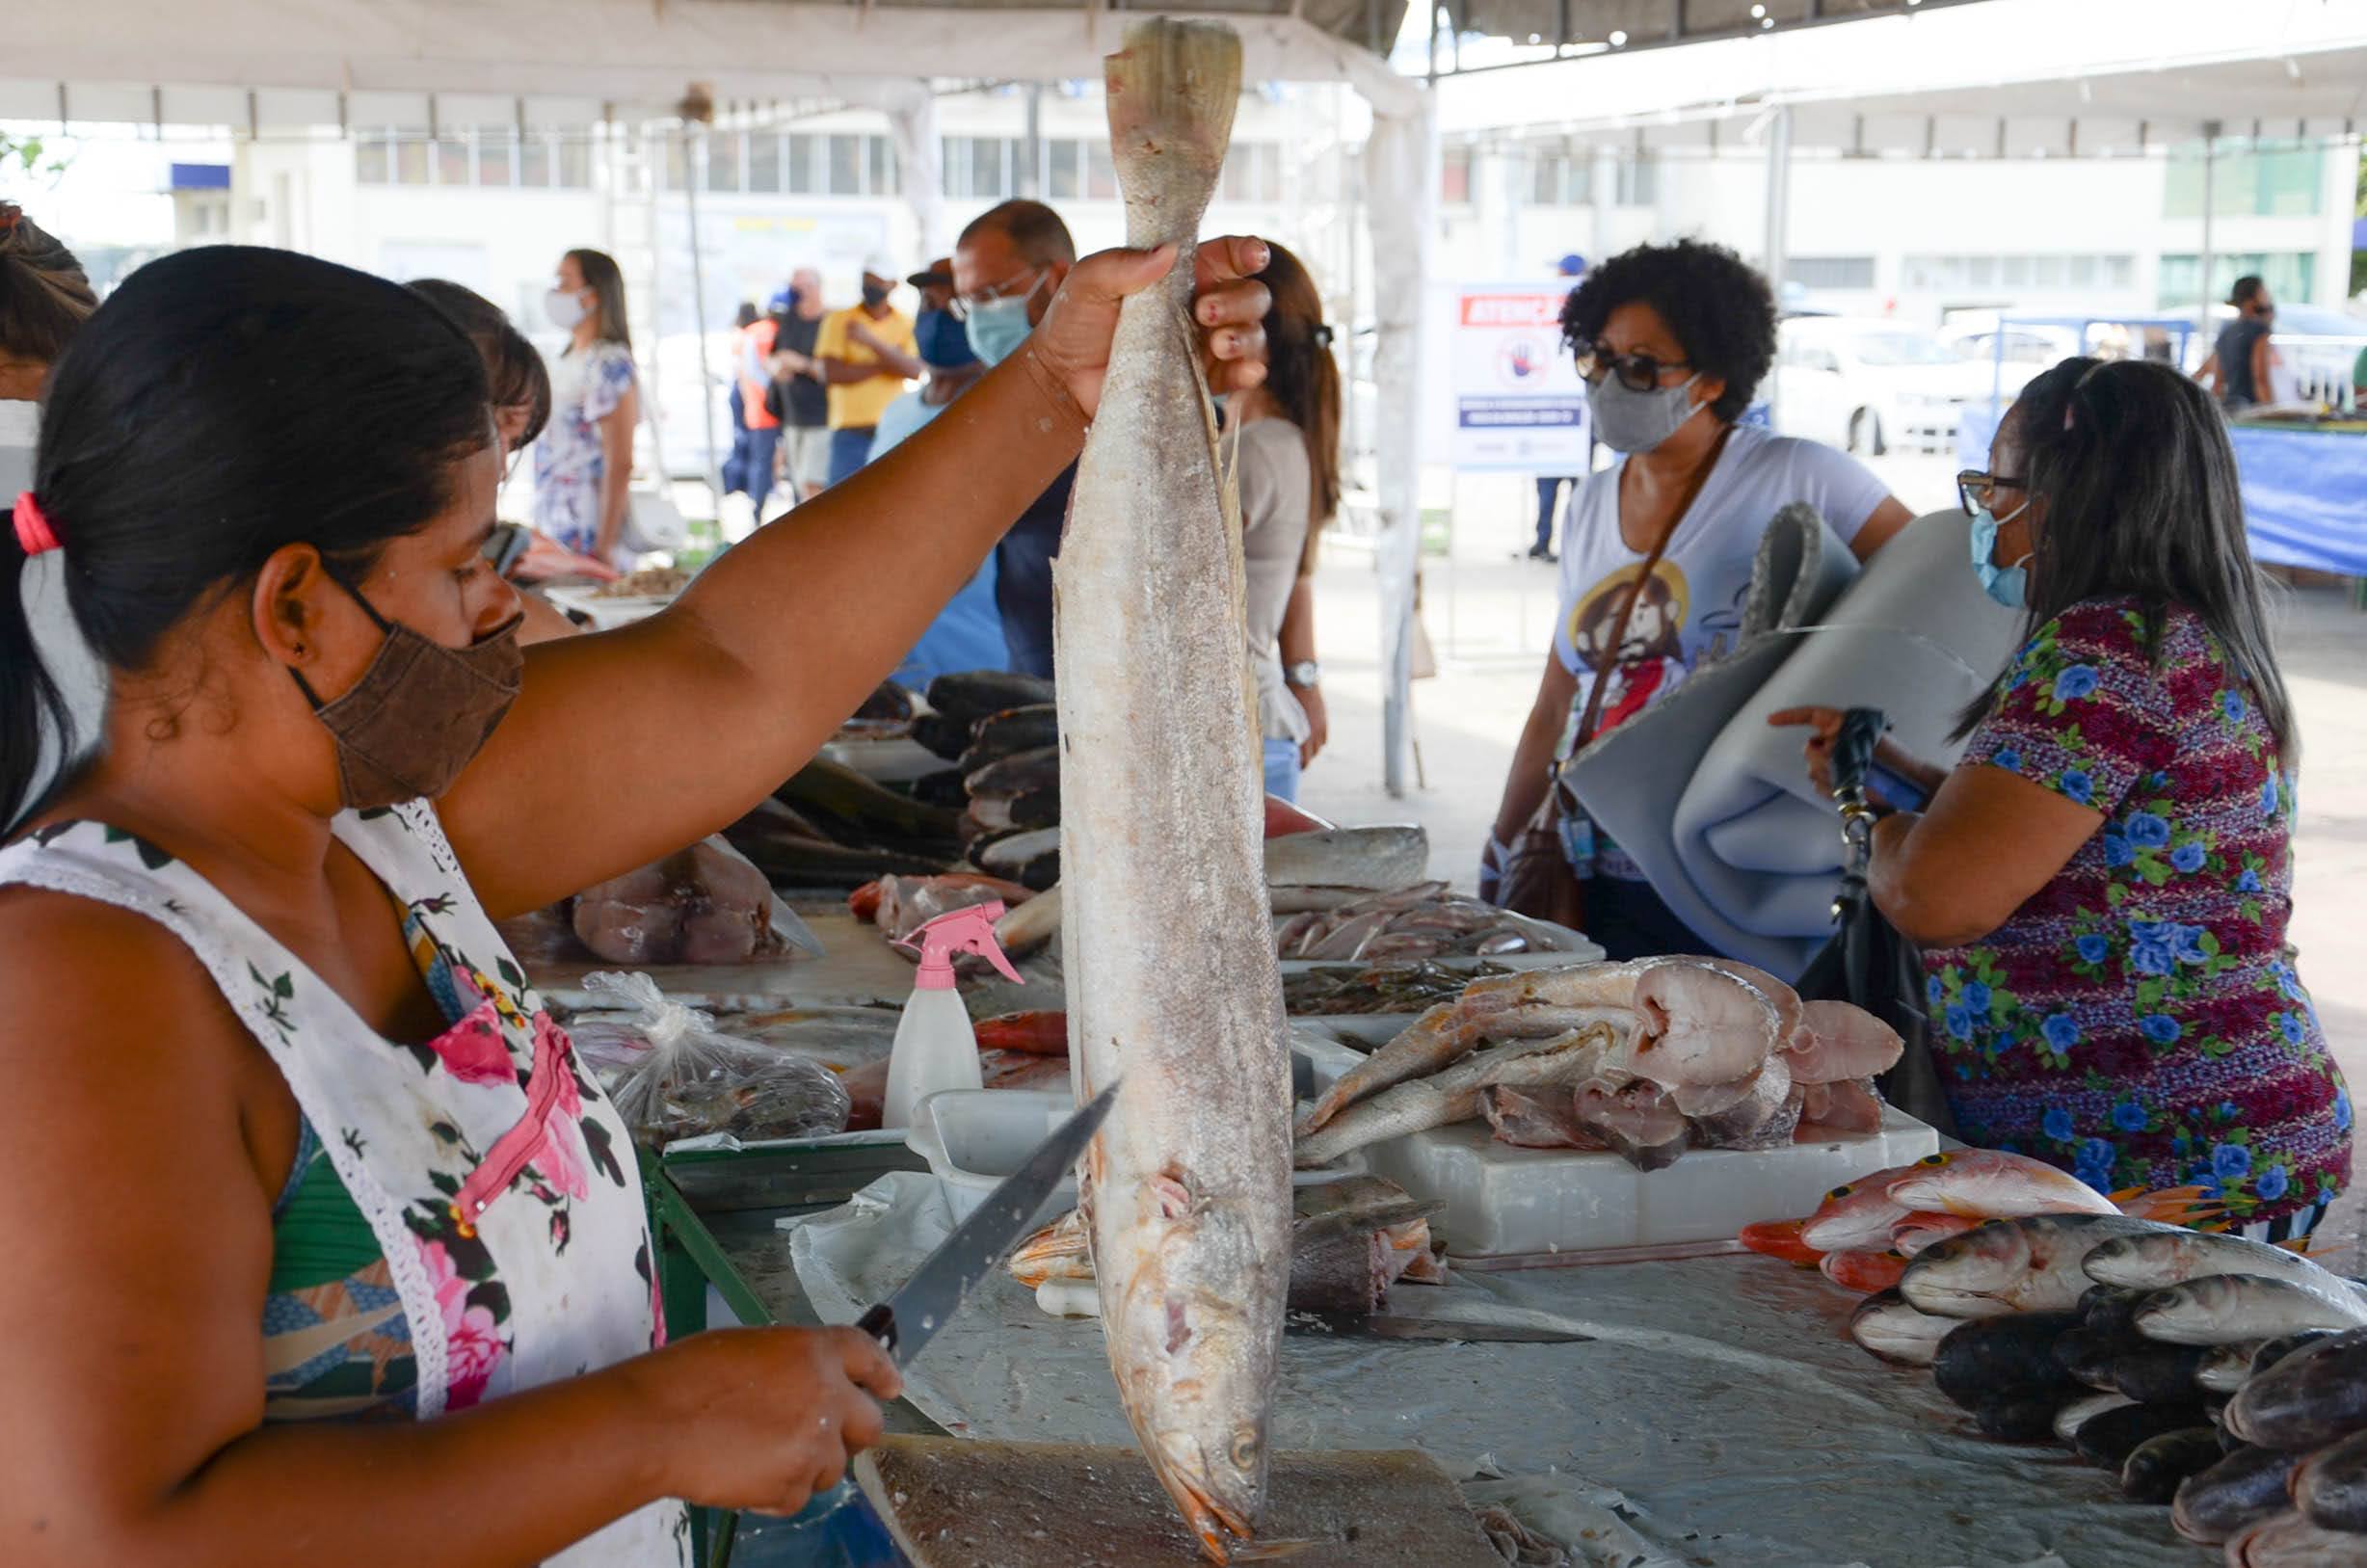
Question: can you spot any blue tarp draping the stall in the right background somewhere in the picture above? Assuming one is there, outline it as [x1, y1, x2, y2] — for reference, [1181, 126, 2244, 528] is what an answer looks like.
[1955, 405, 2367, 578]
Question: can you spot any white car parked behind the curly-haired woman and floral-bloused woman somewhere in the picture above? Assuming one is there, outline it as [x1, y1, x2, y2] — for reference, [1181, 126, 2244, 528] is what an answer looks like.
[1775, 315, 1997, 457]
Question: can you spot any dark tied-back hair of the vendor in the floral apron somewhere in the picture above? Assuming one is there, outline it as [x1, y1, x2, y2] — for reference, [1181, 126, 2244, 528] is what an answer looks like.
[0, 247, 492, 824]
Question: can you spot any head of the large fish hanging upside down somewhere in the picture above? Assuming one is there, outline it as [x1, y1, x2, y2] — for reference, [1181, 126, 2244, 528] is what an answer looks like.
[1103, 1206, 1290, 1563]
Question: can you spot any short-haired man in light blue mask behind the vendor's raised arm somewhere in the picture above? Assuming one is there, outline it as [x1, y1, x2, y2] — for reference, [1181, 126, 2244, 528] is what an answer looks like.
[954, 201, 1077, 679]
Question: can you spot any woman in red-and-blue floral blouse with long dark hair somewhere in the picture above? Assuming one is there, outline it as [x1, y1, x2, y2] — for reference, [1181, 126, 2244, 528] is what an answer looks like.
[1779, 360, 2351, 1241]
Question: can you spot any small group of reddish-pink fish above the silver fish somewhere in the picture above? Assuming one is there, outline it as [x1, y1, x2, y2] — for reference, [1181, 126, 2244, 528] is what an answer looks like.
[1740, 1149, 2218, 1293]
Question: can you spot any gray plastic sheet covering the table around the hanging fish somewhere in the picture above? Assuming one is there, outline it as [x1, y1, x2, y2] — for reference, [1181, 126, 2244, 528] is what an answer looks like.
[785, 1173, 2199, 1568]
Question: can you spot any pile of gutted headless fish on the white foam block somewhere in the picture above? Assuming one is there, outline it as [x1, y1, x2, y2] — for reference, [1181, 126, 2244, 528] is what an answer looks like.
[1294, 957, 1901, 1170]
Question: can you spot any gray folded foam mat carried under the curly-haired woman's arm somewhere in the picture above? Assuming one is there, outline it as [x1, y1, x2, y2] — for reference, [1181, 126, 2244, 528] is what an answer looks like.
[1562, 504, 2021, 978]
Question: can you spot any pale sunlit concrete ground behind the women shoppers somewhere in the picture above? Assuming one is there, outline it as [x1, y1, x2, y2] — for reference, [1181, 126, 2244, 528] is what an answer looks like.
[1302, 455, 2367, 1274]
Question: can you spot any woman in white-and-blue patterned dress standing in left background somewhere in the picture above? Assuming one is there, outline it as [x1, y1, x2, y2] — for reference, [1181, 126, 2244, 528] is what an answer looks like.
[535, 252, 642, 566]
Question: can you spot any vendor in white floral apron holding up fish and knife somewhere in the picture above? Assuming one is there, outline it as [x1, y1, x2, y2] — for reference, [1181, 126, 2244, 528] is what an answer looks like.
[0, 239, 1266, 1568]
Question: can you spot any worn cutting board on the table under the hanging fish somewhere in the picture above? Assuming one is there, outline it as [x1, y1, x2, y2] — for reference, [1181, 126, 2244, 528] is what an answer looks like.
[855, 1438, 1503, 1568]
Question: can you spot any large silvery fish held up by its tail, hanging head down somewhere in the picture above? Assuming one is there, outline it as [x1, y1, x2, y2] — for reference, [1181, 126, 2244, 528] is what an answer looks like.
[1053, 19, 1290, 1561]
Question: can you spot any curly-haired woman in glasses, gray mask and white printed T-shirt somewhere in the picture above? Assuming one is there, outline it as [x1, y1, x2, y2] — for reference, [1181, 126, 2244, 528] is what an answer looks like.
[1479, 239, 1908, 957]
